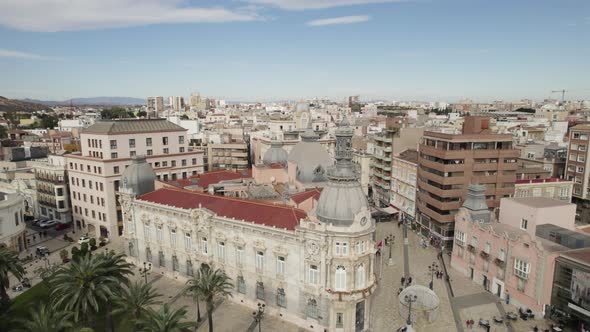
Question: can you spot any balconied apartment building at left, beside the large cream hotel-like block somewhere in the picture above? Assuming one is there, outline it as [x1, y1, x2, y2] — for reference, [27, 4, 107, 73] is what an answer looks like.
[35, 155, 72, 223]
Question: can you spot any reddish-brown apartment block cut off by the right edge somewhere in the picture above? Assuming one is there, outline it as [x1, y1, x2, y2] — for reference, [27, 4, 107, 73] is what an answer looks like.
[565, 124, 590, 224]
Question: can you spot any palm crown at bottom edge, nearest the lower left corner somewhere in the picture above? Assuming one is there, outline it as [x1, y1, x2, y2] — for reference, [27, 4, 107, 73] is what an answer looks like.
[19, 303, 74, 332]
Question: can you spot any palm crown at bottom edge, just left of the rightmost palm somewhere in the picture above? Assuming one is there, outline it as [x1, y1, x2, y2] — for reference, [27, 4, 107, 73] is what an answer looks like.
[139, 304, 193, 332]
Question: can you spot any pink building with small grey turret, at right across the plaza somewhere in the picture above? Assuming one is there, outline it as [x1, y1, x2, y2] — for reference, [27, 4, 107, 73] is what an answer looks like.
[451, 185, 575, 317]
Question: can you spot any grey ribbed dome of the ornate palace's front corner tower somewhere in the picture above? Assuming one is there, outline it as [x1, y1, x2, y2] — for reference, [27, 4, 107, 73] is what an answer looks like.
[316, 181, 369, 226]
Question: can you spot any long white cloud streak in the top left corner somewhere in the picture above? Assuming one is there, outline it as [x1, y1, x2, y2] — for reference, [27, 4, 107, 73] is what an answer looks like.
[0, 0, 258, 32]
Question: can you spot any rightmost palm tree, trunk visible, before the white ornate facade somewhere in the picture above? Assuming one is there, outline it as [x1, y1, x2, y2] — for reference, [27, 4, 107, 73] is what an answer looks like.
[185, 264, 234, 332]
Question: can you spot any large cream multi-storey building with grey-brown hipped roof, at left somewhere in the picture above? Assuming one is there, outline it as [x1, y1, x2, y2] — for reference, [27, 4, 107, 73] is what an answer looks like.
[66, 119, 203, 237]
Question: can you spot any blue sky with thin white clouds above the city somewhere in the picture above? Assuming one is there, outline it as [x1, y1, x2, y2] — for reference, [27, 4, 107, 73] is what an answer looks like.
[0, 0, 590, 101]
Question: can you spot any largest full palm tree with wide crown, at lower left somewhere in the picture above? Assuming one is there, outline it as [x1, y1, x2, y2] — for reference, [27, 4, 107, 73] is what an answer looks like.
[50, 254, 132, 331]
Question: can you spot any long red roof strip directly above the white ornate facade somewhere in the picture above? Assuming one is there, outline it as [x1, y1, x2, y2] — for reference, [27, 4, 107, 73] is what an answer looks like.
[137, 188, 307, 230]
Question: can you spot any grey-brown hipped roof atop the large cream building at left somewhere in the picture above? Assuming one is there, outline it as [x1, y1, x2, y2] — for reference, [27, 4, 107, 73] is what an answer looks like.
[82, 119, 186, 135]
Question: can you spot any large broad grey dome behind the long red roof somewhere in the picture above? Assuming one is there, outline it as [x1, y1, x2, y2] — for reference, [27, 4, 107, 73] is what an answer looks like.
[288, 140, 334, 183]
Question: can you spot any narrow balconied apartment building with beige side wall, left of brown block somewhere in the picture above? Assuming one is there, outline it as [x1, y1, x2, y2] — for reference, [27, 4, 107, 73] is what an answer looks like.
[371, 117, 424, 207]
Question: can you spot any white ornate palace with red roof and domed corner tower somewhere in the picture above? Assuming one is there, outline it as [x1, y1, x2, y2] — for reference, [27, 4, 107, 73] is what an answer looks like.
[120, 115, 376, 332]
